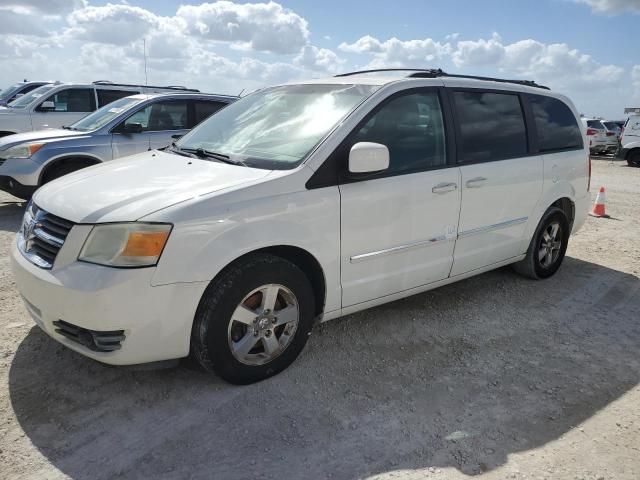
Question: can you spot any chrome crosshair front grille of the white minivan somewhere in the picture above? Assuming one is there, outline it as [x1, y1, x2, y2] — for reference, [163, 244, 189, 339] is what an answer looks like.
[18, 203, 74, 268]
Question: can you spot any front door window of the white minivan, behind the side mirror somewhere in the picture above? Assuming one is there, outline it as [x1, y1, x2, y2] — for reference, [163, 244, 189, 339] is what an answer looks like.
[350, 92, 446, 175]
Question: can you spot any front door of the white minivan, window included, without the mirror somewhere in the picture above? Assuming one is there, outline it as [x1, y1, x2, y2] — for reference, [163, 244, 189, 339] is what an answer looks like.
[340, 89, 460, 307]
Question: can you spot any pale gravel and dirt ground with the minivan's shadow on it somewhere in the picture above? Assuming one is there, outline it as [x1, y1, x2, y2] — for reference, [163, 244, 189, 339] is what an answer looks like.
[0, 161, 640, 480]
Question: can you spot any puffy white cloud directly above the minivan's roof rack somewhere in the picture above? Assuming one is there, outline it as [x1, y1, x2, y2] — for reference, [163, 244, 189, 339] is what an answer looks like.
[338, 35, 450, 68]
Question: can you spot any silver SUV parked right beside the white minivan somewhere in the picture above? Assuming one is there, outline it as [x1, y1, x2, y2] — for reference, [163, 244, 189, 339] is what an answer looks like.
[0, 93, 237, 199]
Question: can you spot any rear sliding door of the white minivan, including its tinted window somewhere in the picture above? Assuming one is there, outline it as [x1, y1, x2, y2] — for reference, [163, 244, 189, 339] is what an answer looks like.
[451, 90, 543, 276]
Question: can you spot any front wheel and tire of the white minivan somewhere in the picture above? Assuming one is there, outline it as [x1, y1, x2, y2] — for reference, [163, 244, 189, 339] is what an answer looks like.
[191, 254, 315, 385]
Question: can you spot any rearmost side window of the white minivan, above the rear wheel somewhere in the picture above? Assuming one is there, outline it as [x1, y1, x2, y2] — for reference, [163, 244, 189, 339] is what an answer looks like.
[529, 95, 582, 152]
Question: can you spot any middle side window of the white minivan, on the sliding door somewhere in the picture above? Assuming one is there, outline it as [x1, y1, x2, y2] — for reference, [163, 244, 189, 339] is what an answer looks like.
[453, 92, 527, 162]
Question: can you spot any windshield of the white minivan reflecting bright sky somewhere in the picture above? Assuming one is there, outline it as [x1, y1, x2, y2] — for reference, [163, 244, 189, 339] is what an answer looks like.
[176, 85, 378, 170]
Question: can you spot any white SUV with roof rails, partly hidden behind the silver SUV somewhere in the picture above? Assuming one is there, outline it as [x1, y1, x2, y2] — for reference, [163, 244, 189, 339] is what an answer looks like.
[0, 80, 198, 137]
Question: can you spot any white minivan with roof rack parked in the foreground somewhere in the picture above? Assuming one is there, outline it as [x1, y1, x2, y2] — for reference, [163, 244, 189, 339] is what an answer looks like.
[11, 70, 590, 384]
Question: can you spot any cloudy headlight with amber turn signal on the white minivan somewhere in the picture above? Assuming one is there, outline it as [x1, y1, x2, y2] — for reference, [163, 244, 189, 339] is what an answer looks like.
[78, 222, 172, 267]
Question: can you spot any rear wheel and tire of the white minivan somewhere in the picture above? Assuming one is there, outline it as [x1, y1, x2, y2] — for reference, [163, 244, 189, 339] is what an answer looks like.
[513, 207, 570, 280]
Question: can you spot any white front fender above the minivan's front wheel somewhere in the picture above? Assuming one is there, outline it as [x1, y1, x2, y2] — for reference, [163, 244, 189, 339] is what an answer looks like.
[145, 187, 340, 311]
